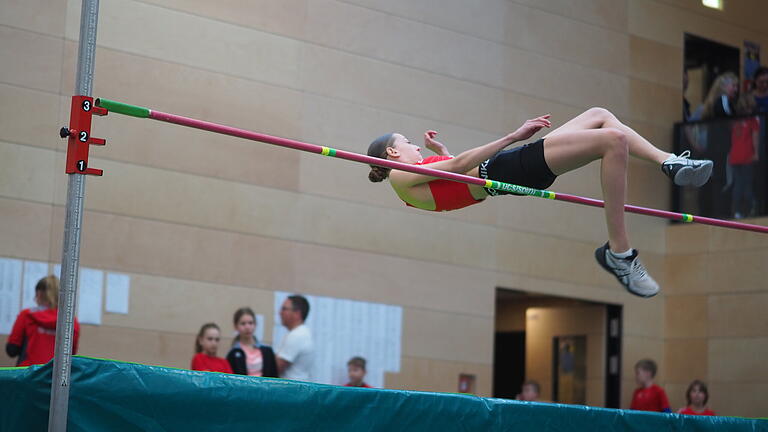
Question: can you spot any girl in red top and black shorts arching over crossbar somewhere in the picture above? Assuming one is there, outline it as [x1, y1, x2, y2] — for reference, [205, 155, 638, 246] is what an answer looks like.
[368, 108, 712, 297]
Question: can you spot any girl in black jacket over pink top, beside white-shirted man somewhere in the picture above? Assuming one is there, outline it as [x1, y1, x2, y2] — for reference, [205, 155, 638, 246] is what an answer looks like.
[227, 307, 277, 378]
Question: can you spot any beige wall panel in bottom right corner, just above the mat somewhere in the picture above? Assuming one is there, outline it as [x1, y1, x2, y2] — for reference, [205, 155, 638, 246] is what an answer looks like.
[707, 382, 768, 418]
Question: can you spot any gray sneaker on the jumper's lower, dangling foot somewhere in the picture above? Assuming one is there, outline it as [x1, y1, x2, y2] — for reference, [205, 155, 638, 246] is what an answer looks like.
[595, 243, 660, 297]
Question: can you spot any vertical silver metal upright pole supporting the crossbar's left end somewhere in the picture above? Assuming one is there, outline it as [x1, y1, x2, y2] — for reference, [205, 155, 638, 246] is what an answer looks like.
[48, 0, 99, 432]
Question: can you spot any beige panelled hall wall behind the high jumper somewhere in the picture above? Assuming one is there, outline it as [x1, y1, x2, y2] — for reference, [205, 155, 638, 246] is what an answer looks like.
[0, 0, 768, 414]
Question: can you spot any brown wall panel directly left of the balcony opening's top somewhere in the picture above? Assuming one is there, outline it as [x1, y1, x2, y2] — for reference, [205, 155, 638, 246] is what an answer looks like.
[629, 36, 683, 90]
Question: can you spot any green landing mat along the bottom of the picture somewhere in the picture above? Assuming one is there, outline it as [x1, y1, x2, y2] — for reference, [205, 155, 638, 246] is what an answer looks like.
[0, 357, 768, 432]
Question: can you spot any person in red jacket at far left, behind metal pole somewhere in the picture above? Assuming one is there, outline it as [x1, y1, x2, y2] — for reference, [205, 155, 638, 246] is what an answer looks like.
[5, 275, 80, 366]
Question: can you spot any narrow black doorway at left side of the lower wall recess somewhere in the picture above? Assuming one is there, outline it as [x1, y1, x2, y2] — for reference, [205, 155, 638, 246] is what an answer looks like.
[493, 331, 525, 399]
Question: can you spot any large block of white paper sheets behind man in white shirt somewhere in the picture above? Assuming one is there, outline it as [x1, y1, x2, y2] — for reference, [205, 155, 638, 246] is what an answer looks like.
[272, 292, 402, 387]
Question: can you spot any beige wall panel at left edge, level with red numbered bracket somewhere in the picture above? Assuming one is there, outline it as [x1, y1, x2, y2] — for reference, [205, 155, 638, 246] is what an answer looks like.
[0, 84, 64, 148]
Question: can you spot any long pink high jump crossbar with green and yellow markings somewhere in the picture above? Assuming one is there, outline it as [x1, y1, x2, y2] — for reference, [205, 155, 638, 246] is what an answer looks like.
[95, 98, 768, 234]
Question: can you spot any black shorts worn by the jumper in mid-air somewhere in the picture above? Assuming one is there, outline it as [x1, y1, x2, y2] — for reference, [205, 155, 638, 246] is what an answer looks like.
[480, 138, 557, 196]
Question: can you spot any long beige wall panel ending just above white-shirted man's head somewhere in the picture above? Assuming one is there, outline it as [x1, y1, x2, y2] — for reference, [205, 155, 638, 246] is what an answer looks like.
[51, 207, 298, 291]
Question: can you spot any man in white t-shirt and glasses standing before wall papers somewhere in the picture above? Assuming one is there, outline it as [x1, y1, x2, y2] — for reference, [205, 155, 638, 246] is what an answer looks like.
[277, 295, 315, 381]
